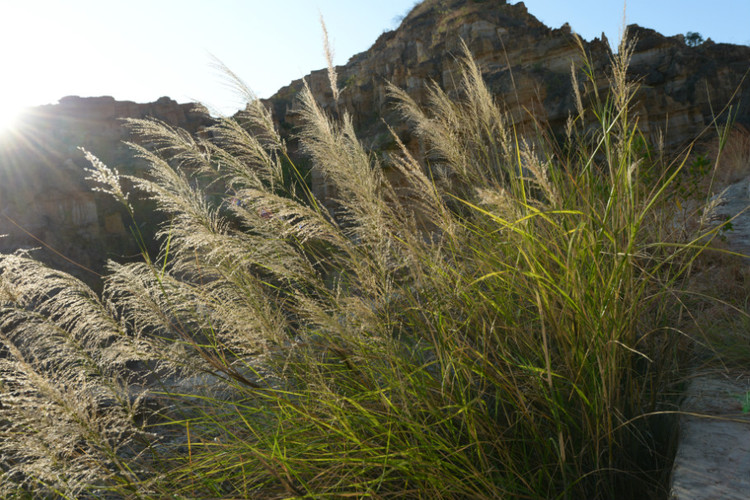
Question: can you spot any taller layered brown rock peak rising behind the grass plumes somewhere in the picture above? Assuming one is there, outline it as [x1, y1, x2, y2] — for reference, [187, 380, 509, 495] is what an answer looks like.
[268, 0, 750, 193]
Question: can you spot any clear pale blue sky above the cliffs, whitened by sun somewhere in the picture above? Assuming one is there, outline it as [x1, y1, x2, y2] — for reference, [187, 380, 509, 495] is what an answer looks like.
[0, 0, 750, 126]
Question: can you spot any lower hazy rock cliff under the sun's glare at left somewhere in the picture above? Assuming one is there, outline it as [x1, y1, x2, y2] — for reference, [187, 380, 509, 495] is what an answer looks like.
[0, 97, 211, 286]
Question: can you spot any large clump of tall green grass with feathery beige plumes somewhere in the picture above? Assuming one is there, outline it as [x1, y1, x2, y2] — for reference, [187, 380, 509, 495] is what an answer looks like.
[0, 34, 716, 498]
